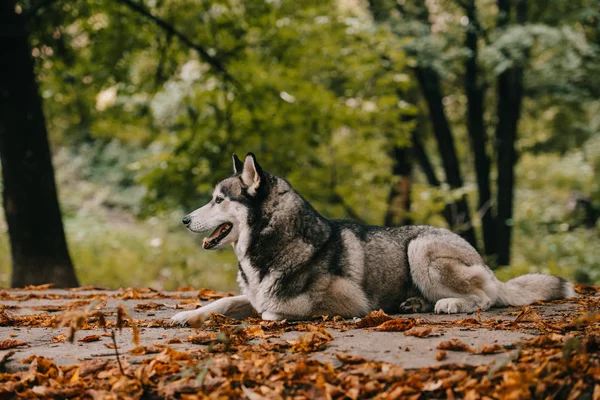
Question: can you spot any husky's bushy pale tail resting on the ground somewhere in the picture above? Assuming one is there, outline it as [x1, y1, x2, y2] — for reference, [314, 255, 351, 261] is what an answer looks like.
[495, 274, 576, 306]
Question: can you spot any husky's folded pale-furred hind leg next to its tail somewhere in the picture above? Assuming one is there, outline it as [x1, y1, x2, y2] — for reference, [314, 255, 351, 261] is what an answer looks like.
[408, 235, 499, 314]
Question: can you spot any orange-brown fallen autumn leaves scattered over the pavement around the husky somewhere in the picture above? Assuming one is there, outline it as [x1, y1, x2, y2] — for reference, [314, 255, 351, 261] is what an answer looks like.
[0, 287, 600, 400]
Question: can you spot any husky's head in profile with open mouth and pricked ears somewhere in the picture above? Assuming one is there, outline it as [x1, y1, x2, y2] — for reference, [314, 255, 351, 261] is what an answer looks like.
[182, 153, 266, 250]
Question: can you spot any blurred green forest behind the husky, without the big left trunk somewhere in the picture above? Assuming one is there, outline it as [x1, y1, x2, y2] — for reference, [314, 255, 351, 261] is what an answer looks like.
[0, 0, 600, 290]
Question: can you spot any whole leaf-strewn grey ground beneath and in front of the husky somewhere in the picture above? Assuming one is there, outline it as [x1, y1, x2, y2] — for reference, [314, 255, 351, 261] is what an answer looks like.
[0, 286, 600, 400]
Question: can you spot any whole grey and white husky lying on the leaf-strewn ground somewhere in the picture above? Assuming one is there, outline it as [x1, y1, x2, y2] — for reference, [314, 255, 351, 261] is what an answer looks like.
[172, 153, 575, 324]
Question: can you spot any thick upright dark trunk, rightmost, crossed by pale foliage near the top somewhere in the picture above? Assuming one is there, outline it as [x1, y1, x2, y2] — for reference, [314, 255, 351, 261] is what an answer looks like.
[496, 0, 526, 265]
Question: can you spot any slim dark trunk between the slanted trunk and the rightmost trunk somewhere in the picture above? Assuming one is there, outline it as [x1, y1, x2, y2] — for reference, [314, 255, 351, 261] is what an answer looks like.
[464, 0, 496, 256]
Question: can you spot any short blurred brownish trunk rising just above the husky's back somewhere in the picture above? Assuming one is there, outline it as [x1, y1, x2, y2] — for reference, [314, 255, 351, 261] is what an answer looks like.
[385, 147, 412, 226]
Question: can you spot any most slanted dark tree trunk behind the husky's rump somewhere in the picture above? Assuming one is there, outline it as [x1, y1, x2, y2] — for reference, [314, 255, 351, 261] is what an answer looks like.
[415, 67, 477, 248]
